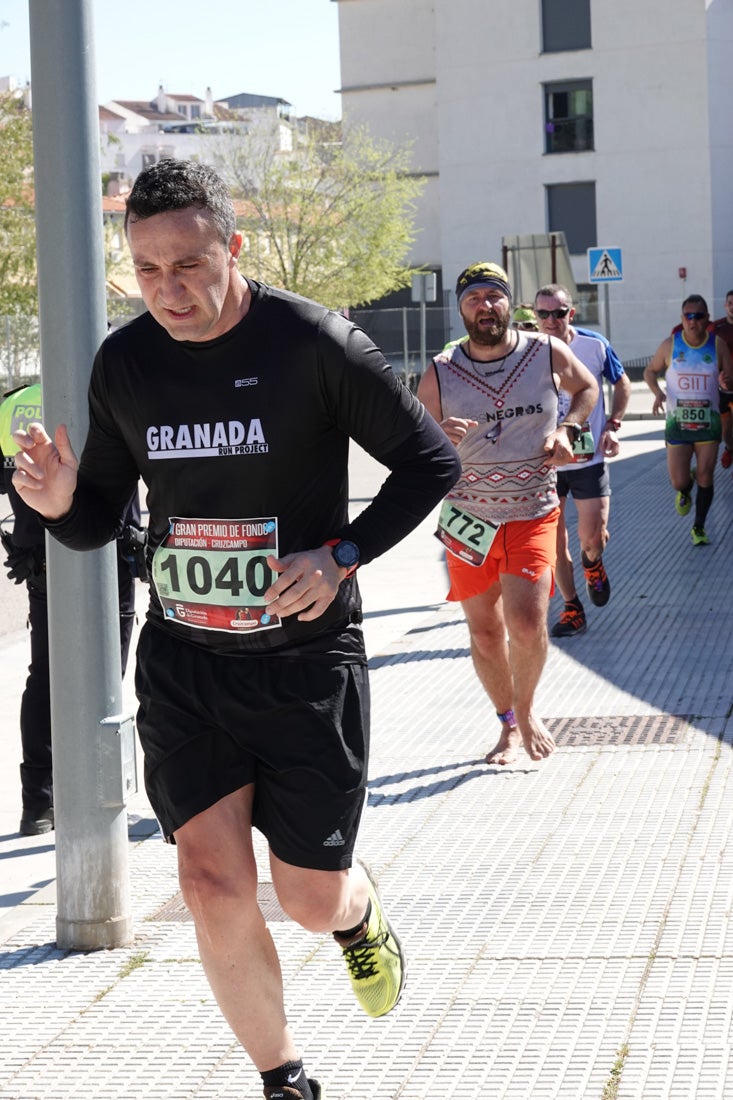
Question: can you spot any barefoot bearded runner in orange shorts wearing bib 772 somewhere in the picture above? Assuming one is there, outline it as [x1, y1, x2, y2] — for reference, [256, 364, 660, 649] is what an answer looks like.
[417, 263, 598, 765]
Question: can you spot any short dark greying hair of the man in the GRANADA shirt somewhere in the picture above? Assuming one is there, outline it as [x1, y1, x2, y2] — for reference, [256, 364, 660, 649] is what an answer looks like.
[124, 158, 237, 245]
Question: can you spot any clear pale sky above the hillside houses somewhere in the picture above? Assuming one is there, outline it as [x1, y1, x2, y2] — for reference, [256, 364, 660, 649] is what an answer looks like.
[0, 0, 341, 119]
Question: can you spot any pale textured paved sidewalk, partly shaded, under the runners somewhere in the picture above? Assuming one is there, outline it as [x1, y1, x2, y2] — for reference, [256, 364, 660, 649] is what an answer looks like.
[0, 421, 733, 1100]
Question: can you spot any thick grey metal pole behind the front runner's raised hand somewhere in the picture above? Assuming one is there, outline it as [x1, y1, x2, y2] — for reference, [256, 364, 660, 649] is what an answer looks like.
[29, 0, 134, 949]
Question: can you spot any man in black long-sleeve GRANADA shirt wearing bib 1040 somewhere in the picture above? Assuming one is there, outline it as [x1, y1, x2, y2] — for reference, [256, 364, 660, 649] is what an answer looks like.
[14, 161, 459, 1100]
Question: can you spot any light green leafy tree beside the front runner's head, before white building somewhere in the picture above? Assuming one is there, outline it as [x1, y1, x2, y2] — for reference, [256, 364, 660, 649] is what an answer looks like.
[218, 125, 424, 308]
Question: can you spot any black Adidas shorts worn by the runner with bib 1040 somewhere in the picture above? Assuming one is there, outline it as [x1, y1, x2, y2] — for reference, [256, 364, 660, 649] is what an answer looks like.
[135, 624, 370, 871]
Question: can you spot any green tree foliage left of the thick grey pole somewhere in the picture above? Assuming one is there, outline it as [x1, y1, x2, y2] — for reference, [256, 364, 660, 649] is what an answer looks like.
[0, 92, 39, 316]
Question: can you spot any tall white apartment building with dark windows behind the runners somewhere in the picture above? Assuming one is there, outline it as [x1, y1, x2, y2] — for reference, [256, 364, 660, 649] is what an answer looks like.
[336, 0, 733, 360]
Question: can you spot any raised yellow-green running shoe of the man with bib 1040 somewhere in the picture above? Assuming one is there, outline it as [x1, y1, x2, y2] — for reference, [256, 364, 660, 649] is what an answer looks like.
[337, 864, 405, 1018]
